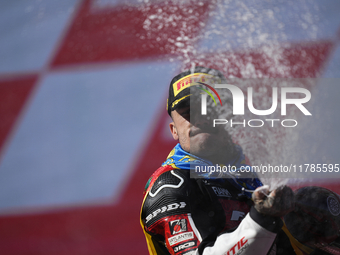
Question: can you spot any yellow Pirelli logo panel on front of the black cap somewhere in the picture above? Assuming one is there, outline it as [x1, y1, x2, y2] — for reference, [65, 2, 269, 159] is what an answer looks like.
[172, 73, 220, 96]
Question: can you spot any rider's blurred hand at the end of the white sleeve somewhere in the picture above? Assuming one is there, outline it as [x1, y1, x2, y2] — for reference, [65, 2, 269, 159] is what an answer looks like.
[252, 185, 294, 217]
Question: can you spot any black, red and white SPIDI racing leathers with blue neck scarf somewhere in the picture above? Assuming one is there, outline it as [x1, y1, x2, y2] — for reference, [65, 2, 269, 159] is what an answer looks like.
[141, 144, 282, 255]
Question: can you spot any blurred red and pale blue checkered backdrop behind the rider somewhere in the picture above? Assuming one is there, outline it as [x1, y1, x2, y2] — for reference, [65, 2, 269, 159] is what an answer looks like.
[0, 0, 340, 255]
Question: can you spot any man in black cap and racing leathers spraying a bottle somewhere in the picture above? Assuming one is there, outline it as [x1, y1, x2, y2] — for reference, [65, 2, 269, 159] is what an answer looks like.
[141, 67, 294, 255]
